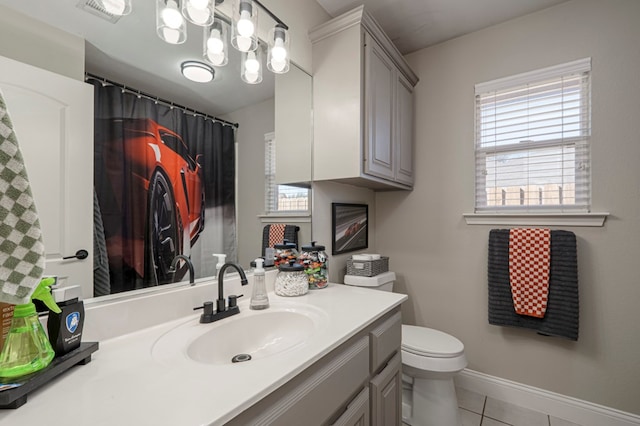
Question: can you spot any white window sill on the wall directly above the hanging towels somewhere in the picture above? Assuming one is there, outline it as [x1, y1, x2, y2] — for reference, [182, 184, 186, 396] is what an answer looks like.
[462, 212, 609, 227]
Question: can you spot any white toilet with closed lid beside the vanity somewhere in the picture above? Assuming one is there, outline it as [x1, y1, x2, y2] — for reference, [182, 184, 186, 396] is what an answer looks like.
[344, 272, 467, 426]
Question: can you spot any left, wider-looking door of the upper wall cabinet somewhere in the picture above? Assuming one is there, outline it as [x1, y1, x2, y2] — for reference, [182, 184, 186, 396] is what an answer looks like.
[364, 32, 396, 180]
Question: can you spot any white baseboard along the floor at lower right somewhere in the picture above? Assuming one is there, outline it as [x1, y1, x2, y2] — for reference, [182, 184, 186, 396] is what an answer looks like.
[455, 369, 640, 426]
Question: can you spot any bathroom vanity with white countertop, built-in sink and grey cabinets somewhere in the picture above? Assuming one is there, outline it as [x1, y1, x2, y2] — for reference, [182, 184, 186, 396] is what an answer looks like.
[0, 273, 407, 425]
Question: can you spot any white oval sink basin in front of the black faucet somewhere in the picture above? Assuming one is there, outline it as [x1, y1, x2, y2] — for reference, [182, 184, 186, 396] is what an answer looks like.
[152, 302, 326, 365]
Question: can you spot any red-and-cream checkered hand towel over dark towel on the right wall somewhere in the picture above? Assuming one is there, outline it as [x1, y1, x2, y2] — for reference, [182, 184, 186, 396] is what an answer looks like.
[509, 228, 551, 318]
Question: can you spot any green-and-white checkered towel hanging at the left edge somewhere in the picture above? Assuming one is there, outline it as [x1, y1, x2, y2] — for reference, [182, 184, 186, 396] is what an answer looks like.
[0, 92, 45, 305]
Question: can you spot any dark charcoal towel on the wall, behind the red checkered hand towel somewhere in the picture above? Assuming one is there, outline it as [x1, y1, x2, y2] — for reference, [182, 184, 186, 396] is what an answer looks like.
[487, 229, 580, 340]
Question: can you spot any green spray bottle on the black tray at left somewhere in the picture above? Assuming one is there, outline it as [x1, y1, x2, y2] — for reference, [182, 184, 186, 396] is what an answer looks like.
[0, 277, 60, 378]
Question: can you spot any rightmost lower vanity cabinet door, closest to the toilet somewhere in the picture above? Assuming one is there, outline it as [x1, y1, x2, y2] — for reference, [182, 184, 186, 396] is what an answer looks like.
[370, 353, 402, 426]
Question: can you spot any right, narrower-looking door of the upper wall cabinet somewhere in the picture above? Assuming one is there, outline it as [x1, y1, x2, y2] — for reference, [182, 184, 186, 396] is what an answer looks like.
[395, 73, 414, 186]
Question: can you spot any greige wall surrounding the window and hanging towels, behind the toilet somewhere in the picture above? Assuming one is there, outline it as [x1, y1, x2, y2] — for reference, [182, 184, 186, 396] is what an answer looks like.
[376, 0, 640, 413]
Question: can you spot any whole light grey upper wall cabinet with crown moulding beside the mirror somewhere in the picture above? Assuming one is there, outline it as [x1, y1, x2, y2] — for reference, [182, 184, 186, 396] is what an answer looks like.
[309, 7, 418, 190]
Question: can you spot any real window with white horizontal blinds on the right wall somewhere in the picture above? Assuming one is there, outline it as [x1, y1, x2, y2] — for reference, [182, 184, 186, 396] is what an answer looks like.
[475, 58, 591, 213]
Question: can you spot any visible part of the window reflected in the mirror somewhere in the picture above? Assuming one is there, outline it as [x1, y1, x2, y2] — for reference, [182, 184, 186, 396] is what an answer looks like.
[264, 133, 309, 214]
